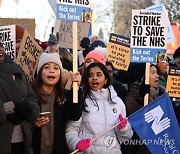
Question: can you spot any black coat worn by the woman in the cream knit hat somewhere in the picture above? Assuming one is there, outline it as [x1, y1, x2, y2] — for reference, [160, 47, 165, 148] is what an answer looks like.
[33, 90, 82, 154]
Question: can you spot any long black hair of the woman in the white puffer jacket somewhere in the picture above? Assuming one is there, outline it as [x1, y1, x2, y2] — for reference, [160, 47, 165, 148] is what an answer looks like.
[81, 62, 113, 112]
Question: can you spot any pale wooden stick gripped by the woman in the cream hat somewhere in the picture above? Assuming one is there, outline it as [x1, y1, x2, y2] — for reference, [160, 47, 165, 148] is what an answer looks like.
[73, 21, 78, 103]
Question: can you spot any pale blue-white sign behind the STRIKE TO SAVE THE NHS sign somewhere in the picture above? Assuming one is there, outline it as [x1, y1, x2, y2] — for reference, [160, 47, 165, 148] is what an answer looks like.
[146, 4, 175, 43]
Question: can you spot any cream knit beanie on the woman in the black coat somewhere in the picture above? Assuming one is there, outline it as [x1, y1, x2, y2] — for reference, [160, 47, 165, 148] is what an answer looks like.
[37, 53, 62, 74]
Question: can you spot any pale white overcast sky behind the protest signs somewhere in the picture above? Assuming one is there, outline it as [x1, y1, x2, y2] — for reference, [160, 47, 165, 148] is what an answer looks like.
[0, 0, 106, 41]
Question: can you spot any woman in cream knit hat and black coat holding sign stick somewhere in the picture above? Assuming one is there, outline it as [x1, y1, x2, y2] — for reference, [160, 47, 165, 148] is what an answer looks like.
[32, 53, 82, 154]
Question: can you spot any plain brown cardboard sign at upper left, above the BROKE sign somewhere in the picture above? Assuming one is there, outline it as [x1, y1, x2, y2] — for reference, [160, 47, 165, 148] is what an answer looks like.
[0, 18, 35, 38]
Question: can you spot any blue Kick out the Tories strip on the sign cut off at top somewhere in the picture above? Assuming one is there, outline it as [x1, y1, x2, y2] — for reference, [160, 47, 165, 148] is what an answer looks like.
[56, 4, 92, 22]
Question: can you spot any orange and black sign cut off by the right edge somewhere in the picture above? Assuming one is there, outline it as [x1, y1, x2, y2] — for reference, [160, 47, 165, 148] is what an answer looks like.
[166, 67, 180, 98]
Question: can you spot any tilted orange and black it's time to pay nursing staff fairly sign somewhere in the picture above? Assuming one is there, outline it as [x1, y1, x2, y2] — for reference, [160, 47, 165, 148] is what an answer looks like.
[107, 33, 130, 71]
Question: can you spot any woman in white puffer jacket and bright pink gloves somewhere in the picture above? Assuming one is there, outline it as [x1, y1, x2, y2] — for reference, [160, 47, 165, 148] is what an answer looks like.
[66, 62, 133, 154]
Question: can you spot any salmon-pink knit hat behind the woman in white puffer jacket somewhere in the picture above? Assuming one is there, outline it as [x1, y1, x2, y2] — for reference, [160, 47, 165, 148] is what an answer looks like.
[84, 50, 106, 65]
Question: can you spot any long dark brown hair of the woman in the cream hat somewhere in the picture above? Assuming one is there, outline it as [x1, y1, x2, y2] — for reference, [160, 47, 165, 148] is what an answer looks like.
[31, 64, 65, 104]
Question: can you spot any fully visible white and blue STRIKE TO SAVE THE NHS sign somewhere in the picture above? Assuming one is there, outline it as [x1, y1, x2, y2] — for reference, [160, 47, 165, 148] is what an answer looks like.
[130, 10, 167, 63]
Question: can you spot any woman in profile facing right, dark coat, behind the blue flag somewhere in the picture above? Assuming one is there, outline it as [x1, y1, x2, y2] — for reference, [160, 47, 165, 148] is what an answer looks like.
[125, 63, 165, 154]
